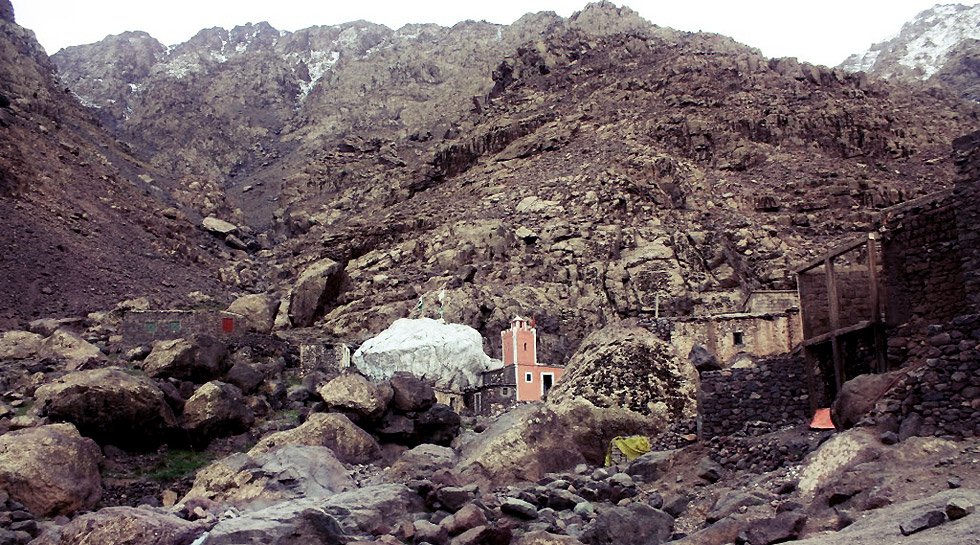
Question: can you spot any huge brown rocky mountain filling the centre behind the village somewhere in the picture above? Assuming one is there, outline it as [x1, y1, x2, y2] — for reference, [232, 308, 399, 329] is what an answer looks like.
[28, 3, 977, 361]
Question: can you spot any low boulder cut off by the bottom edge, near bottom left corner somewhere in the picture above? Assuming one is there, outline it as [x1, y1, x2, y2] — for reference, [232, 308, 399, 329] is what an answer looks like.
[31, 507, 206, 545]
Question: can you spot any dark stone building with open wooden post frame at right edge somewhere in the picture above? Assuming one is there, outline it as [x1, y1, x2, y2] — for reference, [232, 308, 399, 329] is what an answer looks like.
[797, 131, 980, 408]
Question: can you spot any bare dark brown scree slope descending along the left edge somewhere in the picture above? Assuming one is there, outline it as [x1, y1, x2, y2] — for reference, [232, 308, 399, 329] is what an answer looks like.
[0, 2, 226, 327]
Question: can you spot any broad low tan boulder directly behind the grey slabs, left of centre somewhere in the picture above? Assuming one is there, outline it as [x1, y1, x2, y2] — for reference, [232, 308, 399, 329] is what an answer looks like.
[249, 413, 381, 464]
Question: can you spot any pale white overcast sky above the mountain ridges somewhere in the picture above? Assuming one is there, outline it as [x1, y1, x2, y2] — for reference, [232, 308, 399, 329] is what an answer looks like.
[12, 0, 980, 66]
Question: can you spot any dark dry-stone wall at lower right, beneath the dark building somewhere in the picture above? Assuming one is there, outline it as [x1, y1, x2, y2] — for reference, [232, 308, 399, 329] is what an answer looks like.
[876, 314, 980, 439]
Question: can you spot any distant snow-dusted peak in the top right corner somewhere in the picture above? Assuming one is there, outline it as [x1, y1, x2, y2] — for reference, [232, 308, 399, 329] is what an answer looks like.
[839, 4, 980, 101]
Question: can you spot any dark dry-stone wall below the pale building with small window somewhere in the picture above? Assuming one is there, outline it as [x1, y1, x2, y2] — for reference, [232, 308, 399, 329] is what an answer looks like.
[698, 357, 810, 439]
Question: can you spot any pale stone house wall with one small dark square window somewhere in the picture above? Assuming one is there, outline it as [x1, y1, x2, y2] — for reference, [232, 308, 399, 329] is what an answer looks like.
[670, 312, 803, 364]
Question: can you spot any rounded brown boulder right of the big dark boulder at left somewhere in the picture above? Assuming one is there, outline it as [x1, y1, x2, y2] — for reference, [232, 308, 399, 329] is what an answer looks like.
[180, 380, 255, 445]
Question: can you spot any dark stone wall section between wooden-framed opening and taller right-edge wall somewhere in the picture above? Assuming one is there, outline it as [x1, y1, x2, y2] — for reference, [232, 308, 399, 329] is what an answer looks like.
[882, 198, 964, 325]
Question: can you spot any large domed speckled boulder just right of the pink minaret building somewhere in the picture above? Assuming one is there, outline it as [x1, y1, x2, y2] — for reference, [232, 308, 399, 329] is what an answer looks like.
[548, 325, 698, 419]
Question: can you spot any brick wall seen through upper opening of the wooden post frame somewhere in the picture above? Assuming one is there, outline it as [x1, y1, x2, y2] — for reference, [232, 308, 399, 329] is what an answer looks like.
[798, 267, 871, 339]
